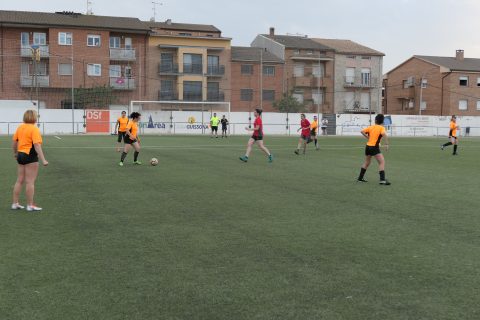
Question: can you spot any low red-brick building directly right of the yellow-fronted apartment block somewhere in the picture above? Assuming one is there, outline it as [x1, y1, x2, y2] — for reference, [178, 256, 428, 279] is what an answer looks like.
[231, 47, 285, 112]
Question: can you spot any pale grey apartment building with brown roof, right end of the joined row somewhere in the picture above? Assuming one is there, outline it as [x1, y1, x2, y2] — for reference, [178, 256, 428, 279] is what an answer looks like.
[313, 39, 384, 113]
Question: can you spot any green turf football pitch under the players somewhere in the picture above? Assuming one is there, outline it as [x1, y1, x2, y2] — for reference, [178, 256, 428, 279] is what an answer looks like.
[0, 136, 480, 320]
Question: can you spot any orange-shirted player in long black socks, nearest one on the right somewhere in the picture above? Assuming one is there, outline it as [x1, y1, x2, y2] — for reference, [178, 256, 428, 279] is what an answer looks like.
[357, 114, 390, 186]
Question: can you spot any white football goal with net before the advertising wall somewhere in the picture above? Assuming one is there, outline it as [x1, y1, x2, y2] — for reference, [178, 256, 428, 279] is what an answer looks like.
[128, 101, 230, 134]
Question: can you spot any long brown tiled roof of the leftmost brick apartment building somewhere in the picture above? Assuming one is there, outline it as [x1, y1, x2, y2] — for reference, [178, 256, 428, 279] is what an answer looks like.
[0, 10, 150, 33]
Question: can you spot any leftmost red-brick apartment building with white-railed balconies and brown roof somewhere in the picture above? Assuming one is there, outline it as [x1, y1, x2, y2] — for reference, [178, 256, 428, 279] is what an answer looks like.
[0, 11, 150, 108]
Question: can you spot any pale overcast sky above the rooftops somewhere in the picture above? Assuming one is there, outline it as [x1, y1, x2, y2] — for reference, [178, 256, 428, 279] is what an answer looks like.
[0, 0, 480, 73]
